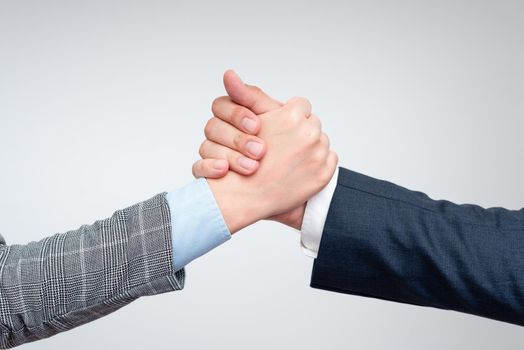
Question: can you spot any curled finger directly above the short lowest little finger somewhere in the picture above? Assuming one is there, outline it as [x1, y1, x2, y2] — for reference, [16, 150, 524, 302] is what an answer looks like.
[199, 140, 260, 175]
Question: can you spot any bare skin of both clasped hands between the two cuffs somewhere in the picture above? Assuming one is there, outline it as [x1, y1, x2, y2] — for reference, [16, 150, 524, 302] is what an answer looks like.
[193, 71, 338, 233]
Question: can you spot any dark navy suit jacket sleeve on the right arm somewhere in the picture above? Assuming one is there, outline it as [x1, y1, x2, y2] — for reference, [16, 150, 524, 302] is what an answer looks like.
[311, 169, 524, 325]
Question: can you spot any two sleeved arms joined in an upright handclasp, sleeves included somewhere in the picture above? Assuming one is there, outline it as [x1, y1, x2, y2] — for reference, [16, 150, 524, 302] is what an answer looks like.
[0, 71, 524, 349]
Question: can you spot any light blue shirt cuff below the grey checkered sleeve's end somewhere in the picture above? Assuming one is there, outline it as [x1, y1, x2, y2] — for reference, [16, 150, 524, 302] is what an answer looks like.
[166, 179, 231, 271]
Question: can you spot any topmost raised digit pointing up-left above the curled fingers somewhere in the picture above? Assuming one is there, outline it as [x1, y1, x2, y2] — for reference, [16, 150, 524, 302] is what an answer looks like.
[224, 69, 282, 114]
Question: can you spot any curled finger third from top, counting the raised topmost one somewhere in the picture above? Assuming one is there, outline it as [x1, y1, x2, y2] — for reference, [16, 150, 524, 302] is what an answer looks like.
[204, 118, 266, 160]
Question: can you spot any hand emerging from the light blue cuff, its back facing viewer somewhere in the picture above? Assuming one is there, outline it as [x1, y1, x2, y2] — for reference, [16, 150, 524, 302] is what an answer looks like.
[205, 98, 338, 233]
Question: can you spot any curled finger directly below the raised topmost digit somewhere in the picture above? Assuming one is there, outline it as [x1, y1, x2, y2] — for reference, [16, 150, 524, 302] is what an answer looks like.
[211, 96, 260, 135]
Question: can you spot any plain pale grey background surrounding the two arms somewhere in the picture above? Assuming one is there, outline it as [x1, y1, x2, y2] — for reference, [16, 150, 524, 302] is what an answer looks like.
[0, 0, 524, 350]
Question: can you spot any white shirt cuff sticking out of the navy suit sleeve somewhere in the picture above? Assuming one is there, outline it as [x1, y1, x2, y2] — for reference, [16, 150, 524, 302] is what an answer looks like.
[300, 167, 338, 259]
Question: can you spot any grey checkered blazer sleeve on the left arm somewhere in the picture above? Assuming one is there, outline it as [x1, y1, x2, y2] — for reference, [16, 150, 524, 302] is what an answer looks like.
[0, 194, 184, 349]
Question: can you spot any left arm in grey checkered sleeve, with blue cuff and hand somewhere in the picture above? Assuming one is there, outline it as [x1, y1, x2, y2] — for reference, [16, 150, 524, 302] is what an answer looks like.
[0, 76, 336, 348]
